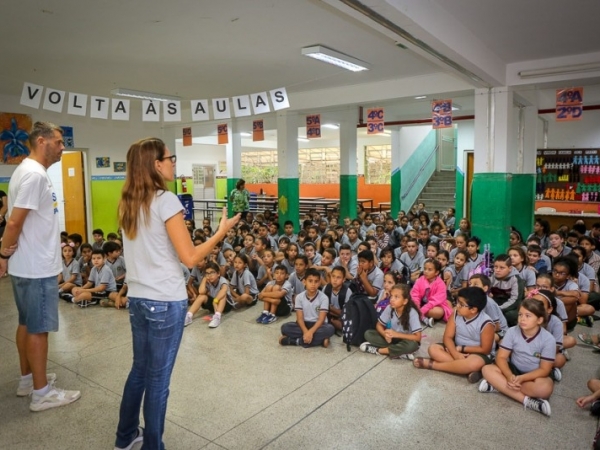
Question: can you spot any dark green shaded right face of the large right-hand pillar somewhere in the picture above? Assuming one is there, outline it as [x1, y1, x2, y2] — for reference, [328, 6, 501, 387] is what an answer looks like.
[510, 174, 536, 239]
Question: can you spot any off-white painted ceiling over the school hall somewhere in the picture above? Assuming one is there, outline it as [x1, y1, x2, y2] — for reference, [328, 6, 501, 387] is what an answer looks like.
[0, 0, 600, 112]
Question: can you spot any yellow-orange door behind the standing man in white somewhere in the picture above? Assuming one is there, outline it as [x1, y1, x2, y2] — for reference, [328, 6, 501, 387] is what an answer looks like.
[62, 151, 88, 242]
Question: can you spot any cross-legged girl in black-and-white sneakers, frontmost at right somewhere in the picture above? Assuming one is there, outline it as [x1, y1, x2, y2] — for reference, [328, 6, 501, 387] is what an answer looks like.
[479, 299, 556, 416]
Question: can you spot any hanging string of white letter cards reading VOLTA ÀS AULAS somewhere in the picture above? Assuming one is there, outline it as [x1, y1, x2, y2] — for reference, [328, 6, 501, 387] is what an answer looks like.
[21, 83, 290, 122]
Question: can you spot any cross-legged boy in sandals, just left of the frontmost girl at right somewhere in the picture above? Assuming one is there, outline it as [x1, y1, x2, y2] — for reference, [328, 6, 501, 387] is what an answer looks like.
[413, 287, 495, 383]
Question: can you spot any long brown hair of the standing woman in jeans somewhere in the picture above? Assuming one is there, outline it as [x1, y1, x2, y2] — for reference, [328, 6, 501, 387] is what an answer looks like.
[119, 138, 167, 239]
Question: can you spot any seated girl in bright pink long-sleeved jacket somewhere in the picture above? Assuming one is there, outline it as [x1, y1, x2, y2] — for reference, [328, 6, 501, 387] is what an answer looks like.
[410, 259, 452, 327]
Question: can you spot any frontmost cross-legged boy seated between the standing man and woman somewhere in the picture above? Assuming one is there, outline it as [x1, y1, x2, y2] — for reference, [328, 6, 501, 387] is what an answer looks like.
[71, 250, 117, 307]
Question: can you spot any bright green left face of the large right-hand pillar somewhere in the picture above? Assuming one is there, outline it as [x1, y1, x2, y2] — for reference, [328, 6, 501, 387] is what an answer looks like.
[471, 173, 512, 255]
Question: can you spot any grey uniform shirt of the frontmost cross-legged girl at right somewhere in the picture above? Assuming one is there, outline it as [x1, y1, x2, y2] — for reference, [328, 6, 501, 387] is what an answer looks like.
[500, 326, 556, 373]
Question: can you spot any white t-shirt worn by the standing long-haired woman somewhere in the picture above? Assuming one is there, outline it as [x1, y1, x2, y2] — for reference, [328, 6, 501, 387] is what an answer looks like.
[123, 191, 187, 301]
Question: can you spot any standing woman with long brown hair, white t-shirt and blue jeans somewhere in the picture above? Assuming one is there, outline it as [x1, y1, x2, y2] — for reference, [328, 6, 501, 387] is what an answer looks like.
[115, 138, 239, 450]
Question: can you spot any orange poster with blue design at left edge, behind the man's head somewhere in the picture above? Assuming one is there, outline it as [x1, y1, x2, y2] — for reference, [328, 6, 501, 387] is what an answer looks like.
[0, 113, 31, 164]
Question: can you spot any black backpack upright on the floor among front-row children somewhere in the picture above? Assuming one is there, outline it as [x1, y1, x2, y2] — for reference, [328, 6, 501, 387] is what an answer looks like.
[342, 294, 377, 351]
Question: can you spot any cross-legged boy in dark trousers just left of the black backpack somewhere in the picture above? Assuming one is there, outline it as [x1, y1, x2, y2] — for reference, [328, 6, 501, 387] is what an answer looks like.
[279, 269, 335, 348]
